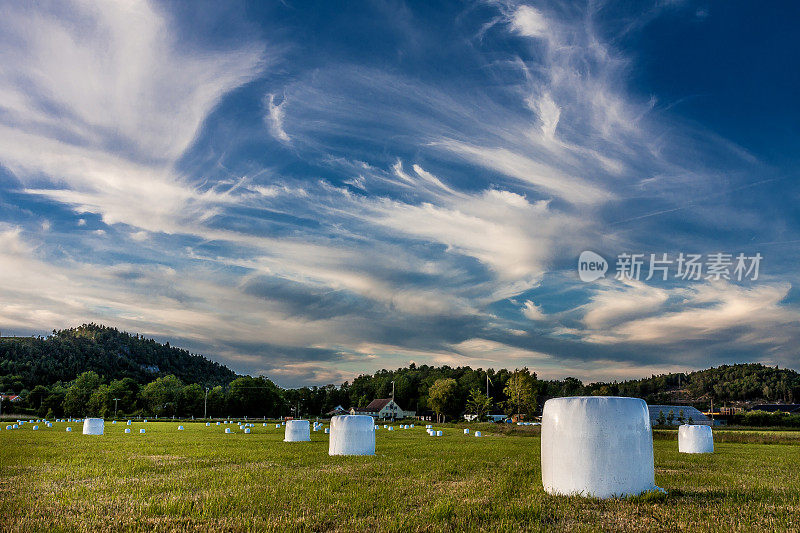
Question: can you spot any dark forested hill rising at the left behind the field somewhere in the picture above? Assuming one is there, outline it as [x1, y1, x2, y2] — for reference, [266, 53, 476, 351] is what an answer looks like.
[0, 324, 236, 390]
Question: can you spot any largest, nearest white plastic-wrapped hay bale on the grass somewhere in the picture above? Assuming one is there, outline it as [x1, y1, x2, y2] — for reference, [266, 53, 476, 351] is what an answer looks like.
[541, 396, 657, 498]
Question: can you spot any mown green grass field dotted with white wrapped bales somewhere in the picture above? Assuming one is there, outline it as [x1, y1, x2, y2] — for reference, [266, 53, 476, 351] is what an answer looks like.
[0, 422, 800, 531]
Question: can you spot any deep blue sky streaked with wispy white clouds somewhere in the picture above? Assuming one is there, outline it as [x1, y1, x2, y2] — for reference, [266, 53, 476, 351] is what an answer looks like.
[0, 1, 800, 386]
